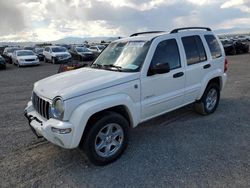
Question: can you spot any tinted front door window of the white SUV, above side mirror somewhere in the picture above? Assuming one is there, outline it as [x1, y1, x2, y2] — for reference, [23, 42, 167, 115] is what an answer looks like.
[150, 39, 181, 70]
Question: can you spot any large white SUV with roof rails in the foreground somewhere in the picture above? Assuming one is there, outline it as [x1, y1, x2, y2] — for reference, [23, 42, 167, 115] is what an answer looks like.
[25, 27, 227, 165]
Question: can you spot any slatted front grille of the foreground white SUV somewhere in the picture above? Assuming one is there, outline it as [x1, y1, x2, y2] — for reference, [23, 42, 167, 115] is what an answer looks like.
[32, 92, 49, 119]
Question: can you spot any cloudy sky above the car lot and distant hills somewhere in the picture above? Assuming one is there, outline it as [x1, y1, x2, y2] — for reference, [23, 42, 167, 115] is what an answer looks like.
[0, 0, 250, 42]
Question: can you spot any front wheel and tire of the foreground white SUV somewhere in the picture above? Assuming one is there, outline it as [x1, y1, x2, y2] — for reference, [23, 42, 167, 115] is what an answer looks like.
[81, 112, 129, 166]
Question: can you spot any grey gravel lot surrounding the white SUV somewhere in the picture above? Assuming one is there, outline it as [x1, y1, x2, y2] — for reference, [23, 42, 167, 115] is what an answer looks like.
[0, 54, 250, 188]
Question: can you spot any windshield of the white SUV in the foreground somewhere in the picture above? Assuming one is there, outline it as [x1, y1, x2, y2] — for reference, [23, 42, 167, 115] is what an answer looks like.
[91, 41, 151, 72]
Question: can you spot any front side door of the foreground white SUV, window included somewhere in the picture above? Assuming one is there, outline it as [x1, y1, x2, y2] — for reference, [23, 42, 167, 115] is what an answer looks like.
[141, 37, 185, 120]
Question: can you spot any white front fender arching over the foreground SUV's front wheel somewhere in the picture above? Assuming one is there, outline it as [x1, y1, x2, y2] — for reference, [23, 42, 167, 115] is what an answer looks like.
[69, 94, 140, 148]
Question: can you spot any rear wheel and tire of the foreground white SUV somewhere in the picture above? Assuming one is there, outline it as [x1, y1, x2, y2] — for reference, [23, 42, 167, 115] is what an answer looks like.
[194, 83, 220, 115]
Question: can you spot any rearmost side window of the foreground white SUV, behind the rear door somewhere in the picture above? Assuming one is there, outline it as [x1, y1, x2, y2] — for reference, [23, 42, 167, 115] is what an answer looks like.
[205, 35, 222, 59]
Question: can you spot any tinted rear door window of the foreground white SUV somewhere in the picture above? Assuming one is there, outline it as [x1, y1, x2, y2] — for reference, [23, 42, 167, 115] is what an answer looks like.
[181, 36, 207, 65]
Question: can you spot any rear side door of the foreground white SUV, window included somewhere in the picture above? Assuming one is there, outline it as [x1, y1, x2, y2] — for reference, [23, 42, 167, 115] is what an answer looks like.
[181, 35, 211, 104]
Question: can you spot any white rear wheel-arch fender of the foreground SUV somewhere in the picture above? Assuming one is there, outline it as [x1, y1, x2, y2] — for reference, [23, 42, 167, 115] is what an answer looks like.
[197, 69, 223, 100]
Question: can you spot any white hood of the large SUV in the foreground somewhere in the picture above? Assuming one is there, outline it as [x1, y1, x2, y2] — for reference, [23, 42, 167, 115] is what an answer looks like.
[34, 68, 140, 100]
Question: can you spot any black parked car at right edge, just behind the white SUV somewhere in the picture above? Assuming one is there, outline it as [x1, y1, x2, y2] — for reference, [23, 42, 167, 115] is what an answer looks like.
[222, 41, 249, 55]
